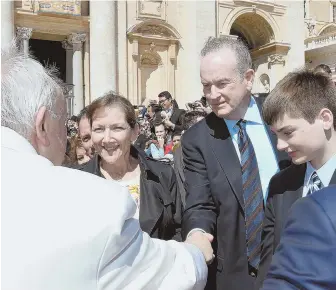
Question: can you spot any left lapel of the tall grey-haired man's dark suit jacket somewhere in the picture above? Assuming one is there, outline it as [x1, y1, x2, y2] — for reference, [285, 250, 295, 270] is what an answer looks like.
[206, 113, 244, 208]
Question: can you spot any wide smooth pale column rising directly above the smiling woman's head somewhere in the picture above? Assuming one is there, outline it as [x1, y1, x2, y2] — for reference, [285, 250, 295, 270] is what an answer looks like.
[90, 1, 118, 101]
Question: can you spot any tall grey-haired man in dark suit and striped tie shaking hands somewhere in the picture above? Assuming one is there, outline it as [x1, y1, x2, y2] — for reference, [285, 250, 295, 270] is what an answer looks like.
[182, 38, 288, 290]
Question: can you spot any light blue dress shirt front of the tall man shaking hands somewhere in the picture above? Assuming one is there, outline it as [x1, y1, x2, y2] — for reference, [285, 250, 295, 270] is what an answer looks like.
[224, 97, 279, 203]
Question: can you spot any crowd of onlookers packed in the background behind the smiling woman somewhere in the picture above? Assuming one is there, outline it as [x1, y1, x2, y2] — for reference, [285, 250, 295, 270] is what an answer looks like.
[64, 91, 211, 166]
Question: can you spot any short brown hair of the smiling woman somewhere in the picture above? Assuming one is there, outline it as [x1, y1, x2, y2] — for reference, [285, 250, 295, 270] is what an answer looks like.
[87, 91, 137, 129]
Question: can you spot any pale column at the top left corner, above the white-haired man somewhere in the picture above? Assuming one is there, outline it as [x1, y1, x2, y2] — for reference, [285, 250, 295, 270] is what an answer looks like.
[1, 1, 15, 46]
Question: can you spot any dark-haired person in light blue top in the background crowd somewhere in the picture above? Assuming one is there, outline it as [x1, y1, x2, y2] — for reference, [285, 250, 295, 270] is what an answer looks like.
[146, 123, 173, 159]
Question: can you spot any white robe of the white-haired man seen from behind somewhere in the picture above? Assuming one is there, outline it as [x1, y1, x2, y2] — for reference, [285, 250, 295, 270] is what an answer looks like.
[1, 127, 207, 290]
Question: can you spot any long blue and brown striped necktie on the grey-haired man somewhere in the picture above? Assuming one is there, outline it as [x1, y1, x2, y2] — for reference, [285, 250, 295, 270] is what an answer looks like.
[237, 120, 264, 269]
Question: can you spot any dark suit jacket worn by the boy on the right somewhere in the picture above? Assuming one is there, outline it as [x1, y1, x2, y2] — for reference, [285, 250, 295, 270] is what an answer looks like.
[255, 163, 336, 289]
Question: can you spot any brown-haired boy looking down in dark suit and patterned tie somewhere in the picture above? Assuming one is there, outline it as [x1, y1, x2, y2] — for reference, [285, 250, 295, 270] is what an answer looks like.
[255, 70, 336, 289]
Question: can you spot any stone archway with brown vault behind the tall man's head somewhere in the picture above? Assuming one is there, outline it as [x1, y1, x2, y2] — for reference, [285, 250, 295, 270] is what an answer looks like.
[221, 7, 290, 93]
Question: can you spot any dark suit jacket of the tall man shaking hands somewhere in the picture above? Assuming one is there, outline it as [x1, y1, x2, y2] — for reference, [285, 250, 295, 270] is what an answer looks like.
[182, 98, 290, 290]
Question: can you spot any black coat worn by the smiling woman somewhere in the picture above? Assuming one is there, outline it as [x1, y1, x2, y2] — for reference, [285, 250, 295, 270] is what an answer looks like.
[78, 146, 182, 241]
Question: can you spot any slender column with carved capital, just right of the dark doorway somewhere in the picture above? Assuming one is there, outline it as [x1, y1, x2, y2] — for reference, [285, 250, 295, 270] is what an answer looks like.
[67, 33, 86, 115]
